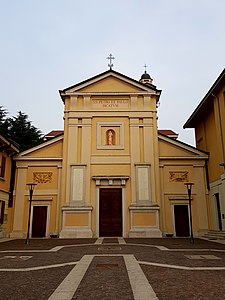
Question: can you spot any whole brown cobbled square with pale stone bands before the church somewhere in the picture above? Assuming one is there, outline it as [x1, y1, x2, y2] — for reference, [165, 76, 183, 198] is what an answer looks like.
[0, 238, 225, 300]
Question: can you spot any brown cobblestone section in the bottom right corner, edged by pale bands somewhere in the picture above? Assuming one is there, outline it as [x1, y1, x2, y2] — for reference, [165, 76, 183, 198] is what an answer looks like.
[142, 266, 225, 300]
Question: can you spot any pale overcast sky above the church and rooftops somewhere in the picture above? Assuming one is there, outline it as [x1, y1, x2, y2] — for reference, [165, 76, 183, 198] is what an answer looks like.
[0, 0, 225, 144]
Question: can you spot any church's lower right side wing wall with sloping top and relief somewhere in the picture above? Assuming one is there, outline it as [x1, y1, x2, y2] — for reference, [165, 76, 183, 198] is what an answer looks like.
[159, 136, 209, 236]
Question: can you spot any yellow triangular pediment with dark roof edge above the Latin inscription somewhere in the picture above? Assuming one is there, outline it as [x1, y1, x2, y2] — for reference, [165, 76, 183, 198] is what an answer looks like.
[60, 70, 159, 95]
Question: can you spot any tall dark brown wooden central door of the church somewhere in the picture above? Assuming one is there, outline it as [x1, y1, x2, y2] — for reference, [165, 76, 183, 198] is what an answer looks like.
[99, 188, 122, 237]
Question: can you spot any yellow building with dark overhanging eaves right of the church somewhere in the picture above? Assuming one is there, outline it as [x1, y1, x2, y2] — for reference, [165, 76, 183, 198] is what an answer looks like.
[184, 69, 225, 230]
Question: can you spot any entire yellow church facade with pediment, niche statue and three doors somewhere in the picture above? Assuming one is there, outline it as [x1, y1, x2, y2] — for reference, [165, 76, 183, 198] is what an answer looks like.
[10, 69, 210, 238]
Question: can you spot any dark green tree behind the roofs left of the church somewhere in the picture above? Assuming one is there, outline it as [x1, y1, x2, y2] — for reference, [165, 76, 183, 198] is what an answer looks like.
[0, 106, 43, 151]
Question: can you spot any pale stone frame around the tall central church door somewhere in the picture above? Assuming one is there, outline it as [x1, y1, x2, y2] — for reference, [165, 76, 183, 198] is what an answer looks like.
[95, 186, 127, 237]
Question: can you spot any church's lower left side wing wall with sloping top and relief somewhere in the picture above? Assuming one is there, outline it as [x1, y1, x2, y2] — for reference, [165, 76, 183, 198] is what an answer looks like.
[10, 137, 62, 238]
